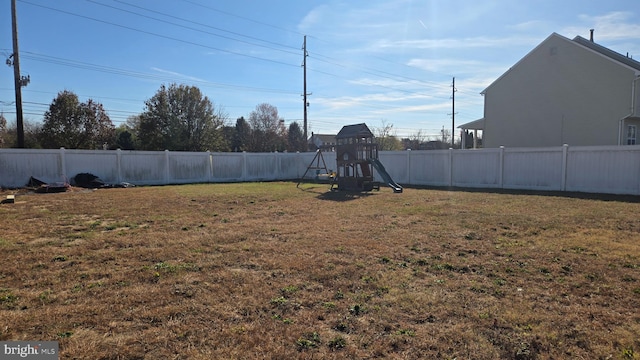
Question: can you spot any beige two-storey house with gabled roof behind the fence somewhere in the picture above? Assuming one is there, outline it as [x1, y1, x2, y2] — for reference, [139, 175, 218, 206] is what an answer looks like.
[460, 32, 640, 148]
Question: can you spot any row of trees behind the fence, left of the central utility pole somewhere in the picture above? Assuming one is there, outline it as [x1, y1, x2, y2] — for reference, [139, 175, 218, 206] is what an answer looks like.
[0, 83, 307, 152]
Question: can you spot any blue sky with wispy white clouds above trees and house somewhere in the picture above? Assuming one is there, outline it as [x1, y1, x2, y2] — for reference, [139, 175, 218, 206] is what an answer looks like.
[0, 0, 640, 140]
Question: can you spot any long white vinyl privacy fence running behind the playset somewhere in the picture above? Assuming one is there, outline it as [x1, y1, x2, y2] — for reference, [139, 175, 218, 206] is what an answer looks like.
[0, 145, 640, 195]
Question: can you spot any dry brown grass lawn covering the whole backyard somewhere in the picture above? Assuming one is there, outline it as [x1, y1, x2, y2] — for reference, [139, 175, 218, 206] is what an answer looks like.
[0, 182, 640, 359]
